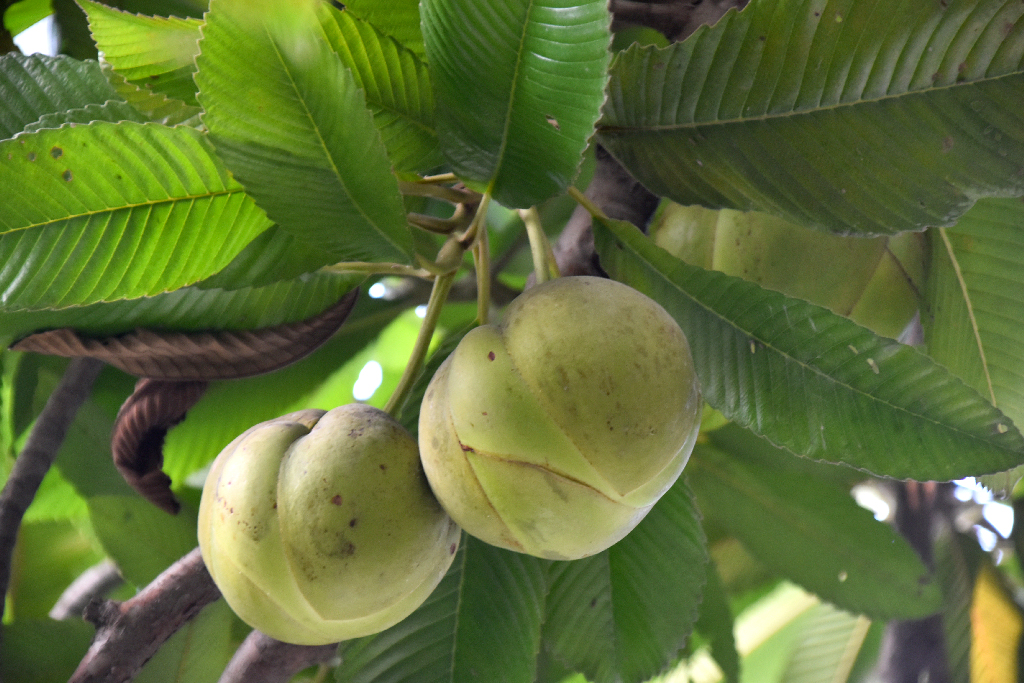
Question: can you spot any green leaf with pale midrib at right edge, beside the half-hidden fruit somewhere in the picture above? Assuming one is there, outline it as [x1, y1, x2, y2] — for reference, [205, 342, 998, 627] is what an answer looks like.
[921, 200, 1024, 489]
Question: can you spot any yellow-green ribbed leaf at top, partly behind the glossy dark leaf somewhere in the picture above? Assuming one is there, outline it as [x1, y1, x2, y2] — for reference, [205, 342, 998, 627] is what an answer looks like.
[321, 5, 441, 173]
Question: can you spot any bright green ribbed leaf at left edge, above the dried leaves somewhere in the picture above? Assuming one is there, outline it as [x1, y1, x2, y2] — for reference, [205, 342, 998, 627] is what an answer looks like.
[0, 122, 268, 310]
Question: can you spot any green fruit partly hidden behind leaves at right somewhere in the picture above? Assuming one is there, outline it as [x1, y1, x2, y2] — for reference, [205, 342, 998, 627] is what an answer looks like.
[650, 203, 926, 338]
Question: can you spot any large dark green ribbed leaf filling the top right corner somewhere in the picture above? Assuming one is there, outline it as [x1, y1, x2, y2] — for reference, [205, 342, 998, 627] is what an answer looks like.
[598, 0, 1024, 233]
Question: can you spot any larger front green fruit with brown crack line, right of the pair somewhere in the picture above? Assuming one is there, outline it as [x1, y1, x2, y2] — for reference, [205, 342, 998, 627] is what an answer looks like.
[420, 276, 702, 559]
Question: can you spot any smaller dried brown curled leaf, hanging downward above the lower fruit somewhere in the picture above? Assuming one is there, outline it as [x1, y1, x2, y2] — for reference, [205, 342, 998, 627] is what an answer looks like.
[111, 379, 209, 514]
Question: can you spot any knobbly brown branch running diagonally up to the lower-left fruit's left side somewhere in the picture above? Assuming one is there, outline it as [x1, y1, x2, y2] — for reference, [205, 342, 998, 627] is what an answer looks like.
[68, 548, 220, 683]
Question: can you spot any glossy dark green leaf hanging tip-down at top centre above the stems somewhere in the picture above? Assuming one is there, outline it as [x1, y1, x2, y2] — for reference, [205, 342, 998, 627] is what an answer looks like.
[422, 0, 610, 208]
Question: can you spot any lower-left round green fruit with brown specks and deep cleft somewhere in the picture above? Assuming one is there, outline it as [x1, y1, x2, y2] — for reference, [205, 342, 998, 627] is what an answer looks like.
[199, 403, 460, 645]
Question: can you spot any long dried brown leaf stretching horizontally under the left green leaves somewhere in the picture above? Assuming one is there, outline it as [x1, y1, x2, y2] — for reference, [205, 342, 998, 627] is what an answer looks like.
[11, 289, 358, 381]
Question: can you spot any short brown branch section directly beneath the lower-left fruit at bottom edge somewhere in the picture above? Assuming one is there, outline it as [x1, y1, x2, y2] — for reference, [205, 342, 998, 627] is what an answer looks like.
[218, 631, 338, 683]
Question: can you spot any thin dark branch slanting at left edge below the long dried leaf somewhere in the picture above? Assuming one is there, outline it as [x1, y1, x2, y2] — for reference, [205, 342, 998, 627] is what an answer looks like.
[0, 358, 103, 651]
